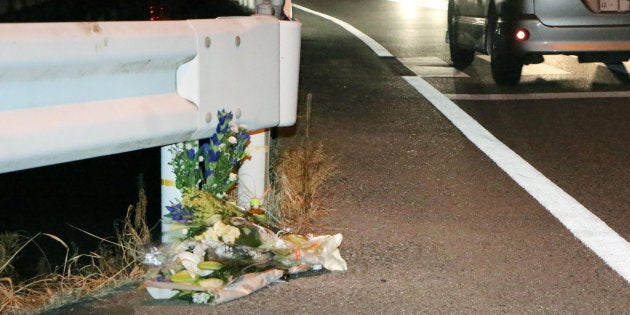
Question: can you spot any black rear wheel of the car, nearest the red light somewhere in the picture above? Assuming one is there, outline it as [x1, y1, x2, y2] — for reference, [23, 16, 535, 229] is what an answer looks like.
[490, 19, 523, 85]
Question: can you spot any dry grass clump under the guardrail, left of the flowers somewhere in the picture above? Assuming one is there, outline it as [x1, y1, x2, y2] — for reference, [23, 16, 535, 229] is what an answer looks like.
[0, 189, 150, 314]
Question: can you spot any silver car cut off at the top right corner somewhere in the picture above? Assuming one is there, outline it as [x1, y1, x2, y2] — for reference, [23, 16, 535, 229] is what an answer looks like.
[446, 0, 630, 85]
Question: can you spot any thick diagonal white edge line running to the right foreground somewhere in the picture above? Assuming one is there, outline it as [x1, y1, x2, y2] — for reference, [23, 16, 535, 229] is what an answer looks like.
[403, 77, 630, 282]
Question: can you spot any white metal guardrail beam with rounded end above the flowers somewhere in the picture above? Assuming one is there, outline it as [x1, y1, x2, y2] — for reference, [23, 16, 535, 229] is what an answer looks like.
[0, 16, 300, 173]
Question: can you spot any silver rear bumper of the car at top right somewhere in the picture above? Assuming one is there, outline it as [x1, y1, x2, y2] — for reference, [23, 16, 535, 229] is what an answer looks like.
[513, 19, 630, 55]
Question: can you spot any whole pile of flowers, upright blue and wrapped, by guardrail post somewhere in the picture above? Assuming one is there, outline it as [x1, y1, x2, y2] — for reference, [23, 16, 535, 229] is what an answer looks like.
[145, 110, 347, 304]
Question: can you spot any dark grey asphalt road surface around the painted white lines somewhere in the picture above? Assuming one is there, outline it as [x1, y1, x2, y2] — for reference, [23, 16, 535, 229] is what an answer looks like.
[14, 0, 630, 314]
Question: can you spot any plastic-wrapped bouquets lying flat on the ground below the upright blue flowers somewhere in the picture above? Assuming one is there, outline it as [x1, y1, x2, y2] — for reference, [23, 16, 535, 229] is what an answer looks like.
[145, 217, 347, 304]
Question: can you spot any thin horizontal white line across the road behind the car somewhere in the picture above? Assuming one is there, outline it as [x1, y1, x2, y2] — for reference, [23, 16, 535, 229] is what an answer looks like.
[446, 91, 630, 101]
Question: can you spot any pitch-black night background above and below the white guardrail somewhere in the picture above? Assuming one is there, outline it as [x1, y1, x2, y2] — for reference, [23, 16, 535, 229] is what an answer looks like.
[0, 0, 251, 277]
